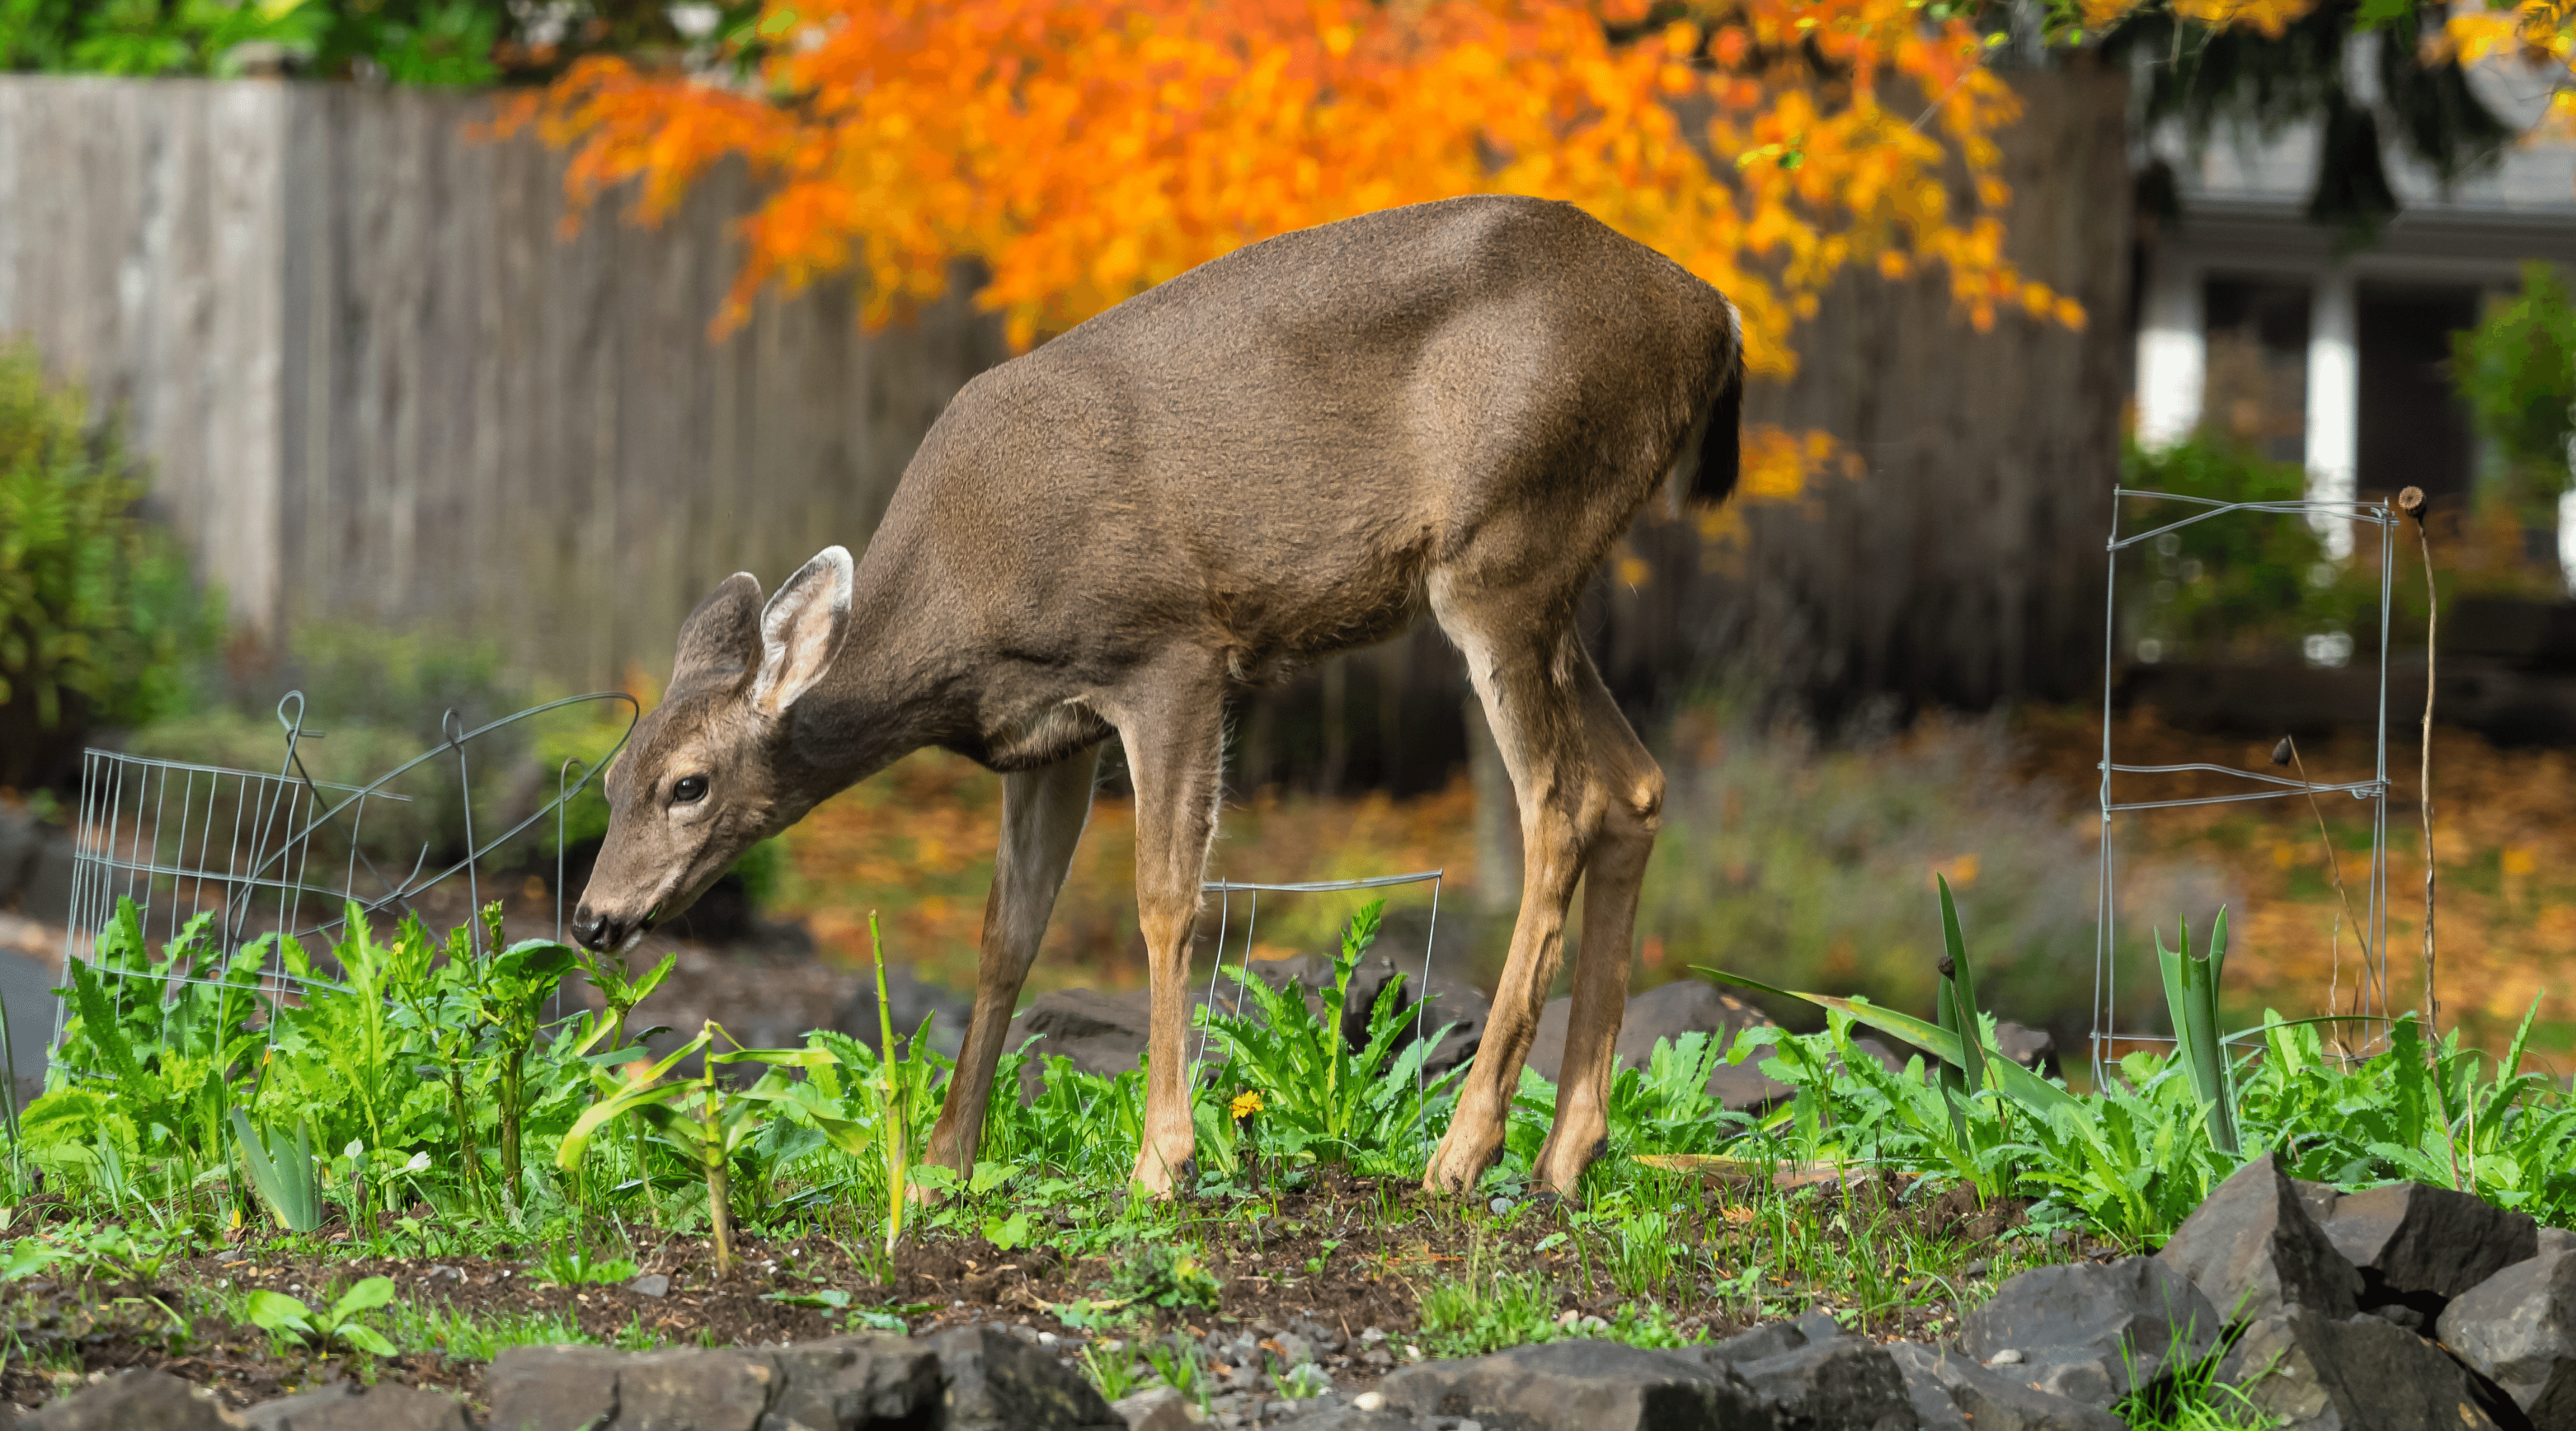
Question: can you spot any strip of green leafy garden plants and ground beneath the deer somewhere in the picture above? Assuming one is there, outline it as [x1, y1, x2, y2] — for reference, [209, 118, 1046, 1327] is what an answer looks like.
[0, 885, 2576, 1426]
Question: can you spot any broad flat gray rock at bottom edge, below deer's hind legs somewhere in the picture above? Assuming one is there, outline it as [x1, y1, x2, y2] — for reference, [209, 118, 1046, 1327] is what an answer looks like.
[1378, 1341, 1770, 1431]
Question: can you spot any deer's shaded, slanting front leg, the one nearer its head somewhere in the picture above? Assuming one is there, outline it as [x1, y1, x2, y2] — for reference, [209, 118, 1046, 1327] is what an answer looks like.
[912, 746, 1100, 1189]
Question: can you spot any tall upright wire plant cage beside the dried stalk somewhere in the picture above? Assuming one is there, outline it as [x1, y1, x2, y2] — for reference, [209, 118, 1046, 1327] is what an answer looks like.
[2087, 487, 2401, 1086]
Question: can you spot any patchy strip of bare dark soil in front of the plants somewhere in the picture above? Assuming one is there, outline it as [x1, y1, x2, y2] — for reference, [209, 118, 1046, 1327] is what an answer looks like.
[0, 1176, 2099, 1405]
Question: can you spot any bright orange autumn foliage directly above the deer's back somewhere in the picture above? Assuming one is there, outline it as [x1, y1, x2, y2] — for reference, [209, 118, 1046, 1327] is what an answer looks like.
[505, 0, 2084, 396]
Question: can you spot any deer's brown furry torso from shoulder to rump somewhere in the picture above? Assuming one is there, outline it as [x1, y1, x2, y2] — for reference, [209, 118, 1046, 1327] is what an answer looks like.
[873, 195, 1736, 674]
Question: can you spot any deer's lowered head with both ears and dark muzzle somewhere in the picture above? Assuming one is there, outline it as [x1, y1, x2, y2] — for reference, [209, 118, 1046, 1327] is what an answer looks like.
[572, 546, 850, 949]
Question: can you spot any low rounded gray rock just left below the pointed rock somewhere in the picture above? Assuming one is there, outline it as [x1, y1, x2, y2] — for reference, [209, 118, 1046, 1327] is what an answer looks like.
[1961, 1256, 2220, 1405]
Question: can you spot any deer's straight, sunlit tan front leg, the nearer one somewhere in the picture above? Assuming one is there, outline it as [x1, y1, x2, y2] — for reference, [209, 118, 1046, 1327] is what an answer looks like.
[1113, 669, 1226, 1197]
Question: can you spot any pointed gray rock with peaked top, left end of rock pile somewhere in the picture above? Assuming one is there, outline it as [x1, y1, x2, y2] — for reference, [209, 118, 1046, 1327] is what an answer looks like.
[2156, 1156, 2362, 1323]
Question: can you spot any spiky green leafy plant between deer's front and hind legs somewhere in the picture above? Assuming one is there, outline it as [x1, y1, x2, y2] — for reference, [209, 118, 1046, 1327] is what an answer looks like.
[1201, 901, 1463, 1173]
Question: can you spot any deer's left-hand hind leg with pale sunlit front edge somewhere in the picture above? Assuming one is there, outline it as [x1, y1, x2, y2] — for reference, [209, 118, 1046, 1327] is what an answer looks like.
[1422, 582, 1626, 1191]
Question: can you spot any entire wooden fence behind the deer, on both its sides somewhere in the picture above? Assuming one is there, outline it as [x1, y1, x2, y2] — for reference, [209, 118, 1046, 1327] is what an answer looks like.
[0, 72, 2130, 785]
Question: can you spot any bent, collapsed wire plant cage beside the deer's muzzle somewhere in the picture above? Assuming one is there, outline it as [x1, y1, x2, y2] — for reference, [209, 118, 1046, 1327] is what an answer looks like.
[44, 693, 639, 1115]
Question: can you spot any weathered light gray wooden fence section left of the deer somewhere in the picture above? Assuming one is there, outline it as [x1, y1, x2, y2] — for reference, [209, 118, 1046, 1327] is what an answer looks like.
[0, 77, 1008, 685]
